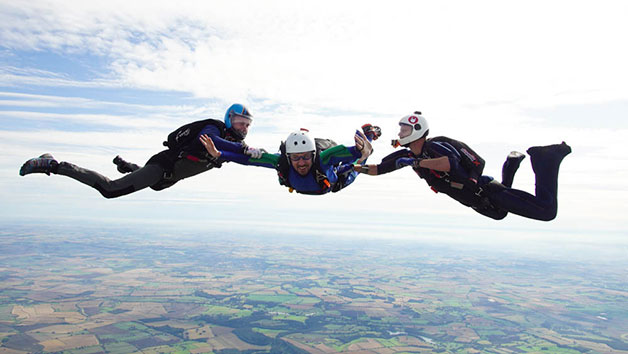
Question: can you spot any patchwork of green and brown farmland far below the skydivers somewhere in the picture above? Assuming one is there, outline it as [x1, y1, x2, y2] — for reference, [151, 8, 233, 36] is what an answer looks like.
[0, 227, 628, 354]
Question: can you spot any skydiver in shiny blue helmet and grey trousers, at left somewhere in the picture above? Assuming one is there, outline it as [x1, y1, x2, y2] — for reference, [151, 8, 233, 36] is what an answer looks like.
[20, 103, 262, 198]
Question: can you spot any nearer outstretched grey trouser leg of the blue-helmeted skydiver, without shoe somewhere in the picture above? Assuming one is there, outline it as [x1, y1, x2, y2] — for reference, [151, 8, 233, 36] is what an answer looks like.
[55, 162, 164, 198]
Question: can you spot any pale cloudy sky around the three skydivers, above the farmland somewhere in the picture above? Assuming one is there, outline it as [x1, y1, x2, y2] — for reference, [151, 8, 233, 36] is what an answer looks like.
[0, 0, 628, 255]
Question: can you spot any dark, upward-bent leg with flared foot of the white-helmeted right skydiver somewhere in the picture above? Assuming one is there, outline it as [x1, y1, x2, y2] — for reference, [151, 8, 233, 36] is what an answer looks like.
[490, 142, 571, 221]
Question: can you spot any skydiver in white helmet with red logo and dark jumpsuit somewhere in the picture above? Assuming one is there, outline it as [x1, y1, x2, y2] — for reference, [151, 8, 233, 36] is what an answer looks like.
[354, 112, 571, 221]
